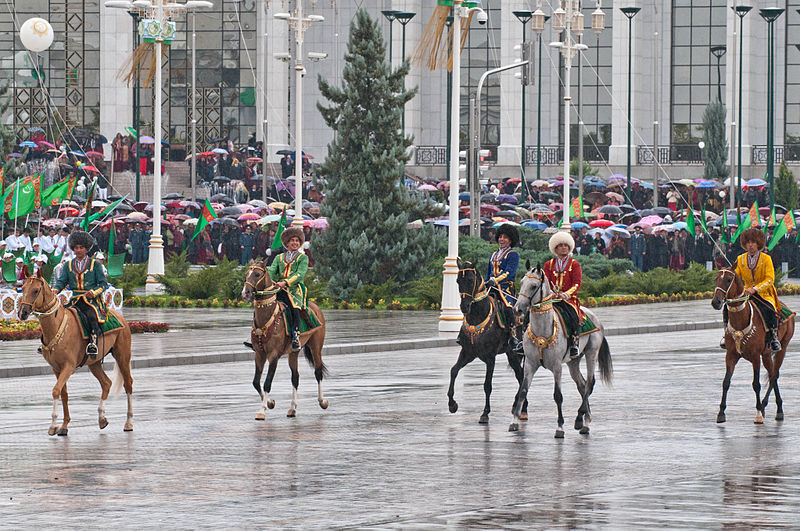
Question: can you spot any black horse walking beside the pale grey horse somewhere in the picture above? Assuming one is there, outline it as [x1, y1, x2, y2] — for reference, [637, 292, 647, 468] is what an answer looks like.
[447, 260, 528, 424]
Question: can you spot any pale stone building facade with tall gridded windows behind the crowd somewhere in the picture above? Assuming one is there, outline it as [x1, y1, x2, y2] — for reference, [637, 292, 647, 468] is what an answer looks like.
[0, 0, 800, 178]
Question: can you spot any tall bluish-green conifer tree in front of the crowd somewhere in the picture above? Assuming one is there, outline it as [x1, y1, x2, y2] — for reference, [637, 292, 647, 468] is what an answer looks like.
[314, 9, 446, 298]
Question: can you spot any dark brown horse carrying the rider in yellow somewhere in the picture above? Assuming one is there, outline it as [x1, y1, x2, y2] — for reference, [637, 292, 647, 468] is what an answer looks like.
[711, 268, 794, 424]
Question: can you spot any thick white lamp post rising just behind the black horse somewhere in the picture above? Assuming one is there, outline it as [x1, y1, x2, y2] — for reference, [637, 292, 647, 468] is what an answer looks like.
[439, 0, 486, 332]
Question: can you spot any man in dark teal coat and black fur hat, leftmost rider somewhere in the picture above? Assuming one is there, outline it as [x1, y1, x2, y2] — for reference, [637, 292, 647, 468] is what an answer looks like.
[53, 231, 108, 359]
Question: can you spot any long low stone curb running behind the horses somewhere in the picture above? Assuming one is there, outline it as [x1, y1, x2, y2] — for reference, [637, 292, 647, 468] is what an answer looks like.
[0, 320, 722, 379]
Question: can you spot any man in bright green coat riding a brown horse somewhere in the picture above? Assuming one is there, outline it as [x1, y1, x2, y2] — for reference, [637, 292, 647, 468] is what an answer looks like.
[267, 227, 308, 350]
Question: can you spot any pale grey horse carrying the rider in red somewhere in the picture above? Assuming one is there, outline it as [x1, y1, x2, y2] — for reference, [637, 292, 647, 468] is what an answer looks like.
[508, 263, 614, 439]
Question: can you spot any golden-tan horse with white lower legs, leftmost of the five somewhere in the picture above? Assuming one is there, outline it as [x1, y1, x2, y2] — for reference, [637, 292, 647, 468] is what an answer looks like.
[17, 276, 133, 435]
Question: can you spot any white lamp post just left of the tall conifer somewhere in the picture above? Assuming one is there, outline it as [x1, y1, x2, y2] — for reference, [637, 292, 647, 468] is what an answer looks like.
[275, 5, 327, 227]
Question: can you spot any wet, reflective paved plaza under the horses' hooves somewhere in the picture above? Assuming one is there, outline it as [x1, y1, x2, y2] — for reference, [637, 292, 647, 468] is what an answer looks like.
[0, 298, 800, 529]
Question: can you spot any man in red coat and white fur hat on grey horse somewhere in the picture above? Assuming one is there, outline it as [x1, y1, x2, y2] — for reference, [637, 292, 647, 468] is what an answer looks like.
[543, 232, 583, 358]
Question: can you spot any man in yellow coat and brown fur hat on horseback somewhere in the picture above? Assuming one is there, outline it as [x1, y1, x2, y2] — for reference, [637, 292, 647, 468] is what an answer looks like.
[724, 228, 781, 351]
